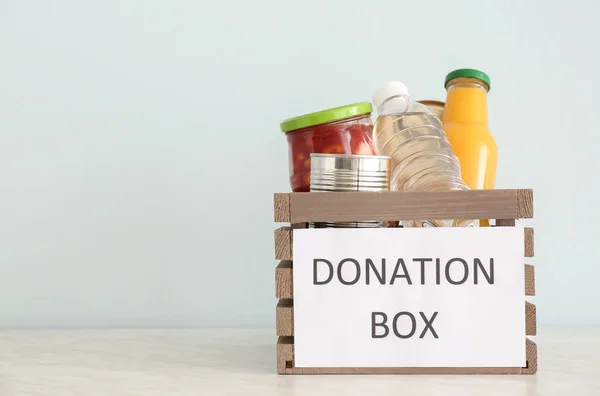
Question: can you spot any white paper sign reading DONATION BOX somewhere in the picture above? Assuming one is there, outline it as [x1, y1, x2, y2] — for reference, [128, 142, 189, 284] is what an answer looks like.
[293, 227, 526, 367]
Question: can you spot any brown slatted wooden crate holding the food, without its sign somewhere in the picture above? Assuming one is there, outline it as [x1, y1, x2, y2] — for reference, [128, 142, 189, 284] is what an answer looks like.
[274, 190, 537, 374]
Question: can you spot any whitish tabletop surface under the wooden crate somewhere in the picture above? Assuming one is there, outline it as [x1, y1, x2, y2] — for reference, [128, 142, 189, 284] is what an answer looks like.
[0, 328, 600, 396]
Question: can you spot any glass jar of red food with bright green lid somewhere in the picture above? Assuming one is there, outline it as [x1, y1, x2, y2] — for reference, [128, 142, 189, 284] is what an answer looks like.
[281, 102, 375, 192]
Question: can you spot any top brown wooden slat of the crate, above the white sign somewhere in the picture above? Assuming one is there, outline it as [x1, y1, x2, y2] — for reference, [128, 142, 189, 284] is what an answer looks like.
[275, 190, 533, 223]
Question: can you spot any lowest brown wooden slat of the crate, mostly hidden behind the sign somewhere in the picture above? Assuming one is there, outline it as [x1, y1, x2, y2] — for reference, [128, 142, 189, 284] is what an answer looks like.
[277, 337, 537, 375]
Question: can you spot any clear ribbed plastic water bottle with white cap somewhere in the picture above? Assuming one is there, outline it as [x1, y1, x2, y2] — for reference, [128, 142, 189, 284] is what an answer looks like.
[372, 82, 477, 227]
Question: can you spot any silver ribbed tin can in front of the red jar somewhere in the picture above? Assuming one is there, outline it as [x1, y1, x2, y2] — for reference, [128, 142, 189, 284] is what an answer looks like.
[309, 153, 390, 228]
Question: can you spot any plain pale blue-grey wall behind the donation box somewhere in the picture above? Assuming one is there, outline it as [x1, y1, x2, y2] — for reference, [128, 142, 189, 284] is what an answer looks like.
[0, 0, 600, 327]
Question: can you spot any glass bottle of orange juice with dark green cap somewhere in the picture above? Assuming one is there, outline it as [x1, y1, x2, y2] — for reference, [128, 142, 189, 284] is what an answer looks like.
[442, 69, 498, 226]
